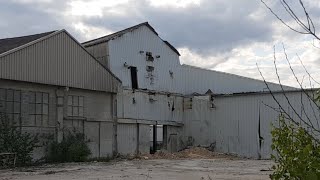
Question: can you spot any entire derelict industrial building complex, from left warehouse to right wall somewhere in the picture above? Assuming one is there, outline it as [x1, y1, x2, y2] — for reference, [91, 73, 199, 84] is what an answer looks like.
[0, 23, 316, 158]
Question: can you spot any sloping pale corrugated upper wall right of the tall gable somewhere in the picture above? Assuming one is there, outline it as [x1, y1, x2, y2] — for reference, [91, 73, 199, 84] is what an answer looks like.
[178, 65, 293, 94]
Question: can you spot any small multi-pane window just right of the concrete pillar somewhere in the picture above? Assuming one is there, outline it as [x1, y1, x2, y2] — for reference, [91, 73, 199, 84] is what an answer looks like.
[68, 95, 84, 117]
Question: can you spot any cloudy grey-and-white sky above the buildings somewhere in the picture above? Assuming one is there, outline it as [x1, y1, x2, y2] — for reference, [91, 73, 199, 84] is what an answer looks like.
[0, 0, 320, 86]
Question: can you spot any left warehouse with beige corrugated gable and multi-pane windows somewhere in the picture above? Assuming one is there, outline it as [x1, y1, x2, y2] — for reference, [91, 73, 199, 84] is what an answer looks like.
[0, 30, 121, 158]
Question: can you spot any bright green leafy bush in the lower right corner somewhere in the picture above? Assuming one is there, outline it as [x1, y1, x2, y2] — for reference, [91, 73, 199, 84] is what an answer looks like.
[270, 116, 320, 180]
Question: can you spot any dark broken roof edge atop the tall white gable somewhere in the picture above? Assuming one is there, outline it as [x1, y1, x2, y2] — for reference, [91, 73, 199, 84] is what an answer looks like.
[82, 22, 180, 56]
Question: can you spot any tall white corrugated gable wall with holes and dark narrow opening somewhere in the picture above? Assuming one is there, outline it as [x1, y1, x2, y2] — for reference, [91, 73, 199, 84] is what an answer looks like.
[108, 26, 180, 92]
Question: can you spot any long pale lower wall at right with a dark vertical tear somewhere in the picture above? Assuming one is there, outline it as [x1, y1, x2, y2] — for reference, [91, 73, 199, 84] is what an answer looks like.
[184, 92, 320, 159]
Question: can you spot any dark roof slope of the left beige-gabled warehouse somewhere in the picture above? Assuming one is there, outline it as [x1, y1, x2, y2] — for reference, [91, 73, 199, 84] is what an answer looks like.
[0, 31, 56, 54]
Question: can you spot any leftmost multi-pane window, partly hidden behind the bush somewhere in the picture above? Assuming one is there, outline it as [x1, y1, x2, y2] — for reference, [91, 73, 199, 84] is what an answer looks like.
[0, 89, 21, 125]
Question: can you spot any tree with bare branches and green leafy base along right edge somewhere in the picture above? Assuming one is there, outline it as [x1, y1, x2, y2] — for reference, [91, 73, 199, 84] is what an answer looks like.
[258, 0, 320, 179]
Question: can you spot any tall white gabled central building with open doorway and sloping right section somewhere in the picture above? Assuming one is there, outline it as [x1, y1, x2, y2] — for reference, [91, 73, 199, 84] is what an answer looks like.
[82, 22, 292, 156]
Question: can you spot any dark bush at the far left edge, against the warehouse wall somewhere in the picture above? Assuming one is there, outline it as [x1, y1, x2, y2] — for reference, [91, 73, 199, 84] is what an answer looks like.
[0, 113, 39, 166]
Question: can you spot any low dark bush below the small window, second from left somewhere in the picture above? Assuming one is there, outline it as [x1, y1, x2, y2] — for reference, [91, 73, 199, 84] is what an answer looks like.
[46, 131, 91, 162]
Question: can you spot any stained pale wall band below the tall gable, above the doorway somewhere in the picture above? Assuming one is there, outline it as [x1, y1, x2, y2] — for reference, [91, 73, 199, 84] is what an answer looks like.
[117, 90, 183, 123]
